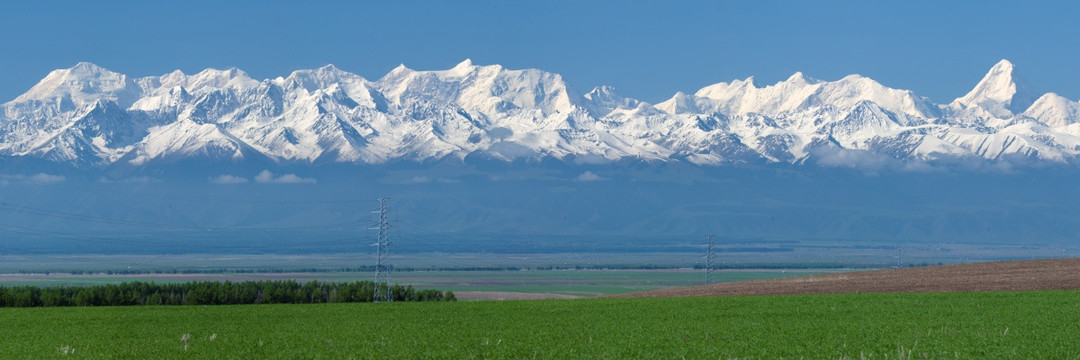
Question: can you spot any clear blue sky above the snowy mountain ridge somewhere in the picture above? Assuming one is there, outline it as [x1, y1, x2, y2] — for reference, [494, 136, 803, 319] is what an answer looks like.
[0, 0, 1080, 103]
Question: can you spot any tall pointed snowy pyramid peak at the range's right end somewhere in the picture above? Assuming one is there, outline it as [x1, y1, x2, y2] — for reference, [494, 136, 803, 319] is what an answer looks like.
[953, 59, 1038, 118]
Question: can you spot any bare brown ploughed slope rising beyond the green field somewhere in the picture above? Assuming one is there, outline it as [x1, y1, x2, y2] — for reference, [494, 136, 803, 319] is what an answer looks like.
[612, 258, 1080, 297]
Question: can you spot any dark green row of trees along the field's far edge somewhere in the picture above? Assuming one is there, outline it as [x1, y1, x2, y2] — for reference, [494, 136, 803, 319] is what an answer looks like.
[0, 280, 457, 307]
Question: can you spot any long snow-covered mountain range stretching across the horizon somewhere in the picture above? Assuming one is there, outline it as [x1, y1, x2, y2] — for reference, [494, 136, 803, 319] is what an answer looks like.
[0, 59, 1080, 168]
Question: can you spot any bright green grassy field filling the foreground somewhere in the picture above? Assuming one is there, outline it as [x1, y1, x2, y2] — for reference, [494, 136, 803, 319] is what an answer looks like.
[0, 291, 1080, 359]
